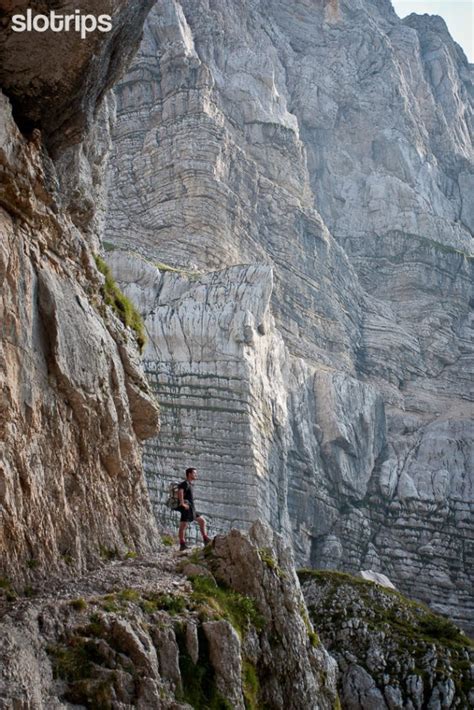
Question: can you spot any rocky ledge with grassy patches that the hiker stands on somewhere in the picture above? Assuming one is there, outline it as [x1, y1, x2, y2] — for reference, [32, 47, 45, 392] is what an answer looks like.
[0, 525, 337, 710]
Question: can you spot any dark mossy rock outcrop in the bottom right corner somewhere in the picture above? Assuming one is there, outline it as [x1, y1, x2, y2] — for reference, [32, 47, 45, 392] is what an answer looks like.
[299, 570, 474, 710]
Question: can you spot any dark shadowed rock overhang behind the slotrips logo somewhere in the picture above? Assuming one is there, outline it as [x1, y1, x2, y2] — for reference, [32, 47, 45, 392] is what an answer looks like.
[0, 0, 153, 157]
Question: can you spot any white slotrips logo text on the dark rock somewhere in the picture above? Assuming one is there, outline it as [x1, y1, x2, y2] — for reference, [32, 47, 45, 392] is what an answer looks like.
[11, 9, 112, 39]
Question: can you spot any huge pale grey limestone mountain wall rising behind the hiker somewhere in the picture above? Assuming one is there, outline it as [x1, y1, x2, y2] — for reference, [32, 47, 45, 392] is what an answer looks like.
[106, 0, 474, 636]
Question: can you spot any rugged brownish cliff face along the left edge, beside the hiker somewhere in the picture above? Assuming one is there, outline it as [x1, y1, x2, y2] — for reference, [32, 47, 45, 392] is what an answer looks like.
[0, 2, 158, 588]
